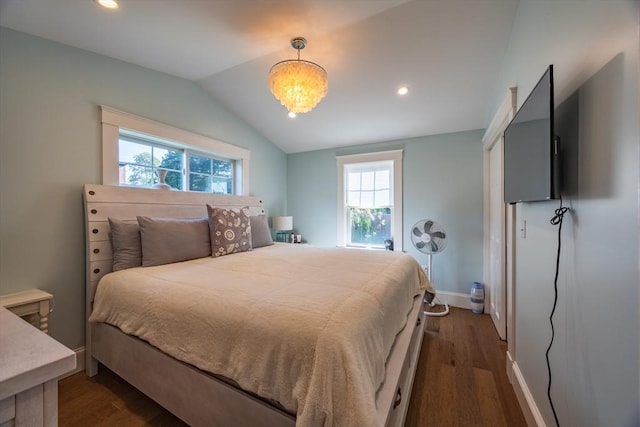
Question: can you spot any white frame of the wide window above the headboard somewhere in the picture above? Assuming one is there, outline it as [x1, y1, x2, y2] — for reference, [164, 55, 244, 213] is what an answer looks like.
[100, 105, 251, 196]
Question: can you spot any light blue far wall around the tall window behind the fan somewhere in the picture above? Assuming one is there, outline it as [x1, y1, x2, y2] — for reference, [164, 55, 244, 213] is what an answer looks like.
[287, 131, 483, 293]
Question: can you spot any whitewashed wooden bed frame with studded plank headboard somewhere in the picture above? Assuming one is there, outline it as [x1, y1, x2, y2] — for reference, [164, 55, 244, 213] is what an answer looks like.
[83, 184, 425, 427]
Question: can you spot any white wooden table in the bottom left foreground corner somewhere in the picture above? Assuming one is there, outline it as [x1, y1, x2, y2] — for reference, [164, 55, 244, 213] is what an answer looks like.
[0, 307, 76, 427]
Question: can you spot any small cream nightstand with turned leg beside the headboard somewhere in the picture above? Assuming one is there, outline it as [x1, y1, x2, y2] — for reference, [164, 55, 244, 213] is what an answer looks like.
[0, 289, 53, 334]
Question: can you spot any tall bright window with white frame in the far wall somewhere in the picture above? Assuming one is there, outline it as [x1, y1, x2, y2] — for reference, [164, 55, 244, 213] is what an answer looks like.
[337, 150, 402, 250]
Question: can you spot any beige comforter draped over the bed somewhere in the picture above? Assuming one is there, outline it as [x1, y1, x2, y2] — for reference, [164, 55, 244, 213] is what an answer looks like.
[90, 244, 433, 426]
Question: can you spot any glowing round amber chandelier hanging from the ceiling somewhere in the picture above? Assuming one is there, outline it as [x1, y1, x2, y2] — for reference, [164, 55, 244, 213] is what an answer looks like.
[267, 37, 329, 113]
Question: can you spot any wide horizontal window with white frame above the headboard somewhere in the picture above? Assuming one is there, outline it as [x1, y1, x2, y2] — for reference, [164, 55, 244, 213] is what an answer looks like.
[101, 106, 250, 195]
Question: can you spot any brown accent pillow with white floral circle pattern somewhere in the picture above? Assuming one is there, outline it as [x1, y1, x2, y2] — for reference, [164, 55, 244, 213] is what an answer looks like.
[207, 205, 251, 258]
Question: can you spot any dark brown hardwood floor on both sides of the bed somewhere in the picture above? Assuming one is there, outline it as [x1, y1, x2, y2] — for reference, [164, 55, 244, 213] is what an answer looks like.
[58, 308, 526, 427]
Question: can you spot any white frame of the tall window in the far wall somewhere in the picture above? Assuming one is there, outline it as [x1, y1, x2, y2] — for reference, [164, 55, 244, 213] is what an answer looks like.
[336, 150, 403, 251]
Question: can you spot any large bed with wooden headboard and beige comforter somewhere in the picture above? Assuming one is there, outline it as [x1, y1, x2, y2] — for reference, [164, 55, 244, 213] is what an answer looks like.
[84, 185, 431, 426]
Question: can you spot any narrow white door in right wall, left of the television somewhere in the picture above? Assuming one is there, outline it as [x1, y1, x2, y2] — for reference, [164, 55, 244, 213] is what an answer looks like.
[485, 139, 507, 340]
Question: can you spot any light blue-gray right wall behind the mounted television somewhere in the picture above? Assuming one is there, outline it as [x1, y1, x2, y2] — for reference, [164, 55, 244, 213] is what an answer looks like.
[496, 0, 640, 427]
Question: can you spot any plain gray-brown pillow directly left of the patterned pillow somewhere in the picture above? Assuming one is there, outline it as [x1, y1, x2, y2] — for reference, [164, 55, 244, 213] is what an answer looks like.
[138, 216, 211, 267]
